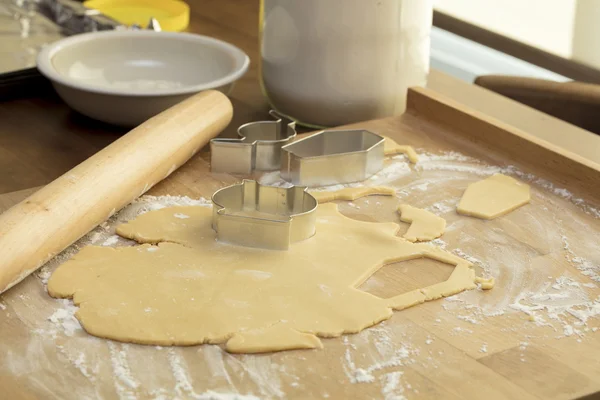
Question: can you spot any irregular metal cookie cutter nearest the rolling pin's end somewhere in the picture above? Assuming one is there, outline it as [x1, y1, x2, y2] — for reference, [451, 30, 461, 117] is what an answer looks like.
[210, 110, 296, 174]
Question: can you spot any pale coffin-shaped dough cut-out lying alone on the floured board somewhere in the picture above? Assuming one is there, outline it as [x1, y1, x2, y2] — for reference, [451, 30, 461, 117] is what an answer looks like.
[456, 174, 530, 219]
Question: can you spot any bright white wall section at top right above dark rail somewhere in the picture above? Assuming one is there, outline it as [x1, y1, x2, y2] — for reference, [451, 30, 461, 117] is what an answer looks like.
[435, 0, 576, 60]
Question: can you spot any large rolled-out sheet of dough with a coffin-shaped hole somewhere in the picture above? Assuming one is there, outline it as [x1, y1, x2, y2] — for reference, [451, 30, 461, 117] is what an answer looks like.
[48, 204, 492, 353]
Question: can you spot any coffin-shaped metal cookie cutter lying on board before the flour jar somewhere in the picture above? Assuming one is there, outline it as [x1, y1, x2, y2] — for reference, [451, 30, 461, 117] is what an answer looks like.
[281, 129, 385, 186]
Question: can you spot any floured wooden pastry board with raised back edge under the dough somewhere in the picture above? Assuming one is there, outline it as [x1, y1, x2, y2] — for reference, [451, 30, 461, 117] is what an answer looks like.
[0, 89, 600, 400]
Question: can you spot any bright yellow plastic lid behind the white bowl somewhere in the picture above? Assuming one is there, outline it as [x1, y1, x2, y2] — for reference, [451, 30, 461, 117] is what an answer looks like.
[83, 0, 190, 32]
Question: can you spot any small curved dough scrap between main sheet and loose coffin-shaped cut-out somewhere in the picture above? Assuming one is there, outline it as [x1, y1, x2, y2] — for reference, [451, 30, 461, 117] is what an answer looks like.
[398, 204, 446, 242]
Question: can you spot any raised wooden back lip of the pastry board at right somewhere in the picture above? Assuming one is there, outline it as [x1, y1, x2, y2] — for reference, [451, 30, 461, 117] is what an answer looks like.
[407, 87, 600, 193]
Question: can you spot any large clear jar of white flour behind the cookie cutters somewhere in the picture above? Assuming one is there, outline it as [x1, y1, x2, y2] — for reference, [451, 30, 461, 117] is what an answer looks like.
[260, 0, 433, 126]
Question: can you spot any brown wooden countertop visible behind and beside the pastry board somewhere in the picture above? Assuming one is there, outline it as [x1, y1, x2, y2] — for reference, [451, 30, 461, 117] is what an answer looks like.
[0, 0, 600, 194]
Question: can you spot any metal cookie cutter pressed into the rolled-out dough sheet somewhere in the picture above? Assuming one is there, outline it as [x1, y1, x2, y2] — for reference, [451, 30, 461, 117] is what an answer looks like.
[212, 179, 317, 250]
